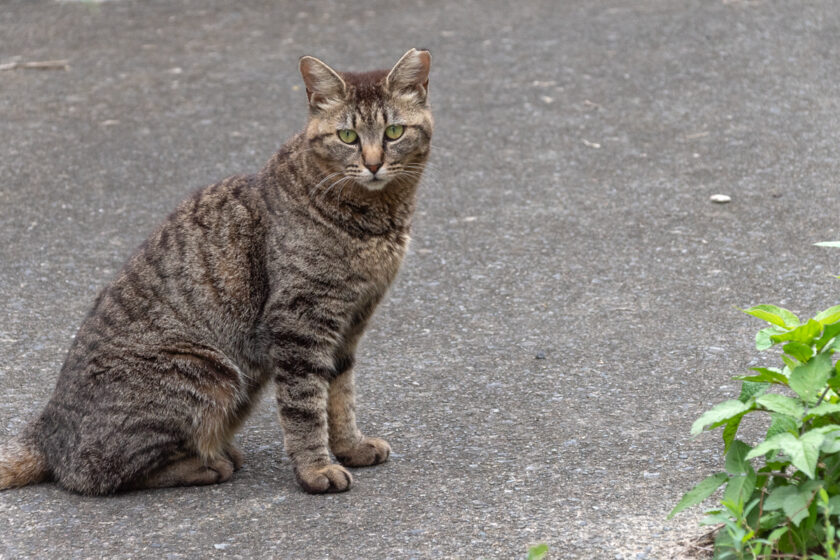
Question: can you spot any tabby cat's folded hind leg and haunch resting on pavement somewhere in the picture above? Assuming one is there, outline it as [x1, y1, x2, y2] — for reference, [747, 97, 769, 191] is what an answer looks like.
[41, 348, 246, 495]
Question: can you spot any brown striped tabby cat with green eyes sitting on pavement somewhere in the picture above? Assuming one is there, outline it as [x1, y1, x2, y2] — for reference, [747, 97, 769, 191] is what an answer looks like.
[0, 49, 433, 495]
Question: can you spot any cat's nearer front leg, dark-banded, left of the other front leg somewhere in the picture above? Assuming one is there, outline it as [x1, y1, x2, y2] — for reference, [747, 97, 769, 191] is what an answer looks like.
[275, 372, 353, 494]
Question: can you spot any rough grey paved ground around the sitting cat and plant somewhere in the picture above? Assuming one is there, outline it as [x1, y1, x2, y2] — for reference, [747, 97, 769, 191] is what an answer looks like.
[0, 0, 840, 559]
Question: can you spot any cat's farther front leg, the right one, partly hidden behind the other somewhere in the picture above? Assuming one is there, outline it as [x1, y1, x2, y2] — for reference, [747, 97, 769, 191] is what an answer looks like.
[327, 367, 391, 467]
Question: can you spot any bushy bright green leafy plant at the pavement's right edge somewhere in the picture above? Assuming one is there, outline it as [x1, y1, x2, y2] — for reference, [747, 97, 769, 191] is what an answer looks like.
[668, 305, 840, 560]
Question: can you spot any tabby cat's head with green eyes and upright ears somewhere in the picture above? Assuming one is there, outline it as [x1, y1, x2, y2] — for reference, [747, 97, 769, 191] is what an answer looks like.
[300, 49, 432, 191]
